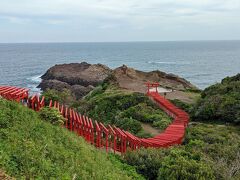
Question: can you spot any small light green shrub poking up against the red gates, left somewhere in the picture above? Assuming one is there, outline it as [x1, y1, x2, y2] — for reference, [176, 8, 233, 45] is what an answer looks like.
[39, 107, 65, 125]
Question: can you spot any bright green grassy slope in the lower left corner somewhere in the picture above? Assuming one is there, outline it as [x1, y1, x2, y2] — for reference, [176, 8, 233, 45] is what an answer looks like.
[0, 99, 142, 179]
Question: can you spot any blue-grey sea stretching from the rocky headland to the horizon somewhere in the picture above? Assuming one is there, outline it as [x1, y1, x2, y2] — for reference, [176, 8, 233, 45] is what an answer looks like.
[0, 41, 240, 91]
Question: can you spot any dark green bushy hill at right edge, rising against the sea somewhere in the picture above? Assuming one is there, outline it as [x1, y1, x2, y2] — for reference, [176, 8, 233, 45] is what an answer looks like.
[192, 74, 240, 124]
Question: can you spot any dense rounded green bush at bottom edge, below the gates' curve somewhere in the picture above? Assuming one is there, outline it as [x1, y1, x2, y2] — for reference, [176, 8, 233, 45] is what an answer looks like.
[125, 147, 214, 179]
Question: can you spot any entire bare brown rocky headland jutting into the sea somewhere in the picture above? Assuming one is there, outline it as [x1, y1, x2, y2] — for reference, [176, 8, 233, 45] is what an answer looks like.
[38, 62, 197, 99]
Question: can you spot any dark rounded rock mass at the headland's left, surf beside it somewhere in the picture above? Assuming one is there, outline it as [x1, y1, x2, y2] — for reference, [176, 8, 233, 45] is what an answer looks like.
[38, 62, 112, 99]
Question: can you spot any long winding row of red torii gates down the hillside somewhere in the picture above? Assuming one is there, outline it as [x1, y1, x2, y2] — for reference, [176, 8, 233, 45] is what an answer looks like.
[0, 83, 189, 154]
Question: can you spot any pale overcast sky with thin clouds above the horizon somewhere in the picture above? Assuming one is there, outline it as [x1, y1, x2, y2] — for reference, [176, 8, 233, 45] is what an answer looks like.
[0, 0, 240, 42]
